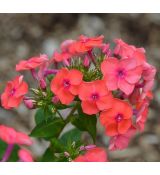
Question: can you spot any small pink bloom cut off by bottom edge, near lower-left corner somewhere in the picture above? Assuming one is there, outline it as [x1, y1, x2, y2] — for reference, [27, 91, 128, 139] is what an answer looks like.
[18, 149, 33, 162]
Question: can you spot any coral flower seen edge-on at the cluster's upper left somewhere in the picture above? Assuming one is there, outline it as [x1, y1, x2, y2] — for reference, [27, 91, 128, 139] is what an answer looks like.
[16, 54, 48, 71]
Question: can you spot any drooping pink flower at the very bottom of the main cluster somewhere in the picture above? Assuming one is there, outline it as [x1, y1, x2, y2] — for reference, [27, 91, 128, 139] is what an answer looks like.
[109, 126, 136, 151]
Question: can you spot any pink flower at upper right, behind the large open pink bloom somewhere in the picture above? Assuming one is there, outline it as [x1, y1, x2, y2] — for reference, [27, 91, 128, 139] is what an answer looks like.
[114, 39, 146, 66]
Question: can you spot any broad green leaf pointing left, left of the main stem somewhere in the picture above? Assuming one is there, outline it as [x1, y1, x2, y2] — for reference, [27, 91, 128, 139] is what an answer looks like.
[30, 118, 65, 138]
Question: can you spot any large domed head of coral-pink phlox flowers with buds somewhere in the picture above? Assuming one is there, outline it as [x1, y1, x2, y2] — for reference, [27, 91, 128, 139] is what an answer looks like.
[1, 35, 156, 161]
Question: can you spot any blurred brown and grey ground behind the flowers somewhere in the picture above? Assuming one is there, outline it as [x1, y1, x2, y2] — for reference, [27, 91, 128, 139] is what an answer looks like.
[0, 14, 160, 161]
